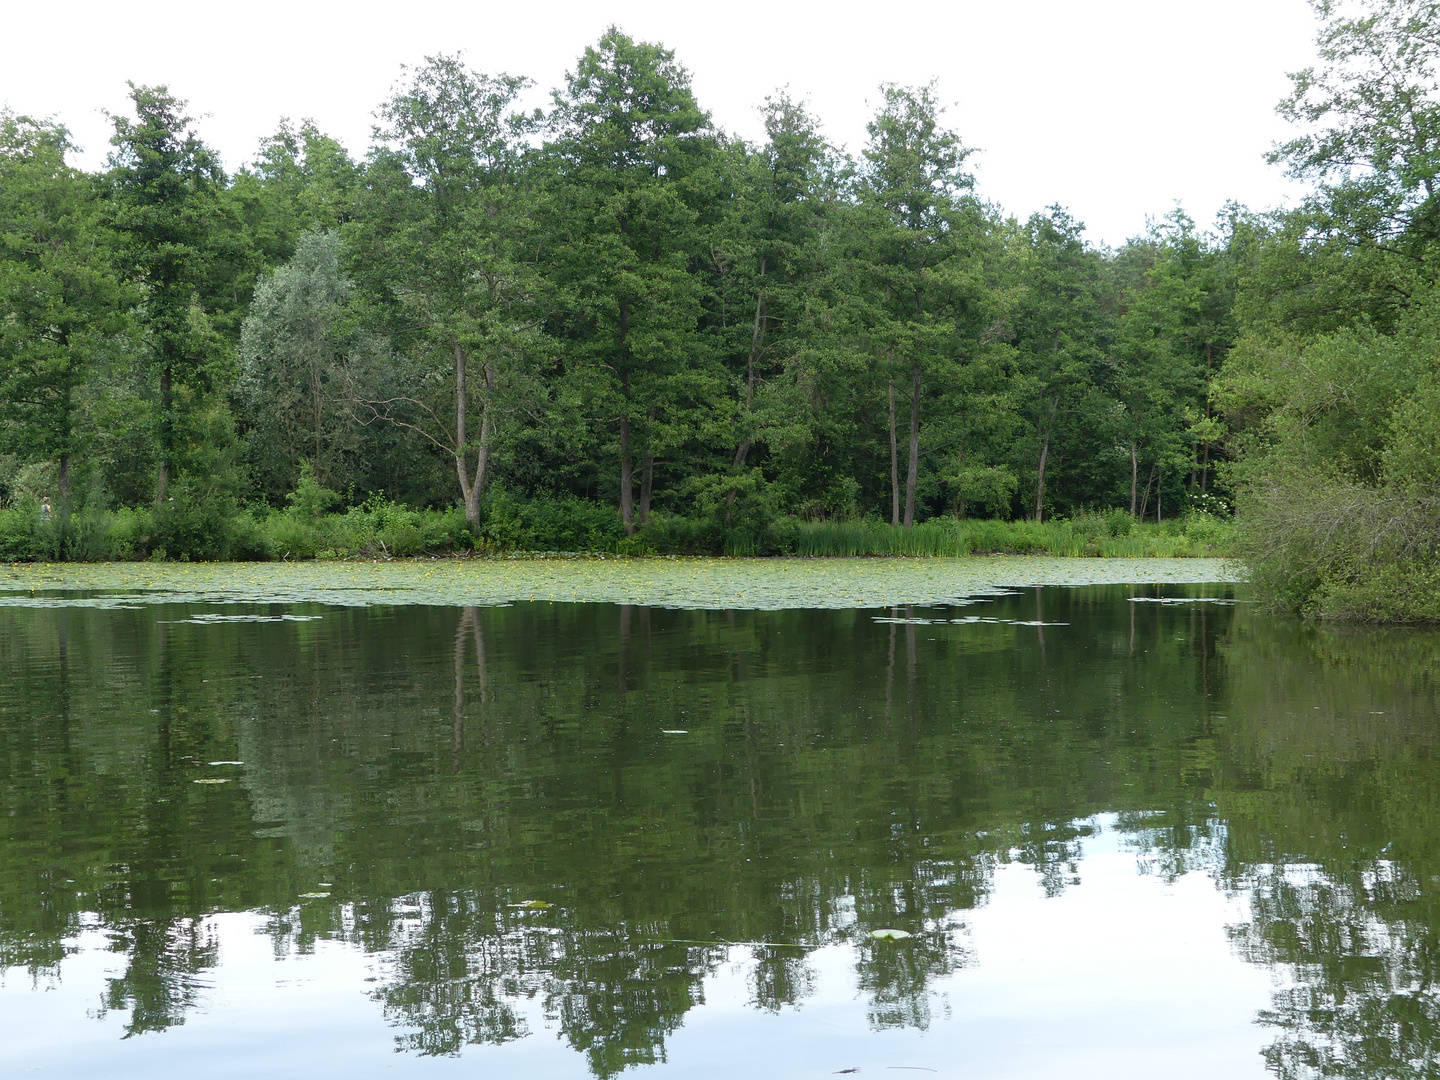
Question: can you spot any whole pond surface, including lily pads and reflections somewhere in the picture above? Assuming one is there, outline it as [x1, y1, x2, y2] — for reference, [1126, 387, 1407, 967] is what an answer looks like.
[0, 560, 1440, 1080]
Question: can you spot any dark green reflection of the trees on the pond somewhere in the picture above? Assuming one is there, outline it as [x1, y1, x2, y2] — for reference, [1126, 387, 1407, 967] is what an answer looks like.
[0, 586, 1440, 1077]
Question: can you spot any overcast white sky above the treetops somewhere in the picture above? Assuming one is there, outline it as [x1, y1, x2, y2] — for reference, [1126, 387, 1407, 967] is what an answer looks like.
[0, 0, 1315, 245]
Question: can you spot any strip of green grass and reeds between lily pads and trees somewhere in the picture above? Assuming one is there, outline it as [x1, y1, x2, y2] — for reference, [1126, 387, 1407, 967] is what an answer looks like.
[0, 500, 1234, 562]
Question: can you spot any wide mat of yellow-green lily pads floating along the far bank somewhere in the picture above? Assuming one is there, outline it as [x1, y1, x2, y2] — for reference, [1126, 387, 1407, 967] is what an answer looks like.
[0, 556, 1241, 609]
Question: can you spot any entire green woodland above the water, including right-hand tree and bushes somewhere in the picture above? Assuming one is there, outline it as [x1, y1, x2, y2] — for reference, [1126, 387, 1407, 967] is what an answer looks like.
[0, 0, 1440, 615]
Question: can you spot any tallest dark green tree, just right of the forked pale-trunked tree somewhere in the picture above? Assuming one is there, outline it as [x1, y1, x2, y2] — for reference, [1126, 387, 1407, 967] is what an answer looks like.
[543, 27, 724, 533]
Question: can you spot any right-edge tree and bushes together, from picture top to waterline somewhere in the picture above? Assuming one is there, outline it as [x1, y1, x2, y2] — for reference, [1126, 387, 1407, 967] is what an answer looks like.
[1215, 0, 1440, 622]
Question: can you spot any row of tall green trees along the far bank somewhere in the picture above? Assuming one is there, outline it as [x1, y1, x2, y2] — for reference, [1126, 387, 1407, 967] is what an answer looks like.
[0, 29, 1238, 544]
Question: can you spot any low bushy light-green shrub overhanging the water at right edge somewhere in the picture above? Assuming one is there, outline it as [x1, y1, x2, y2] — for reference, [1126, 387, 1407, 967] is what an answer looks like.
[1221, 292, 1440, 622]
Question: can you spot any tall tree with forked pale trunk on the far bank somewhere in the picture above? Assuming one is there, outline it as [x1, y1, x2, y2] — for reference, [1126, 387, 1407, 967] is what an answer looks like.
[347, 56, 544, 527]
